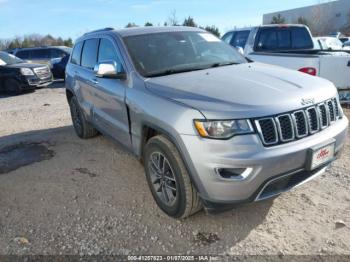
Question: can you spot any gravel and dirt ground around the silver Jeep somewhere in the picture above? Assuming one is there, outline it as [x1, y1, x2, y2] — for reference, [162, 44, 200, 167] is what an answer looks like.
[0, 85, 350, 256]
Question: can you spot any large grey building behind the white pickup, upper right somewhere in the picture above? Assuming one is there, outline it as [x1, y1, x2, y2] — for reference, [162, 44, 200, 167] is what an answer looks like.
[263, 0, 350, 35]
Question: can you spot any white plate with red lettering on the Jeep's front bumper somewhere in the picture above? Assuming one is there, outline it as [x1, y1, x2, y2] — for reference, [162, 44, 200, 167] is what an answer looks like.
[306, 141, 335, 171]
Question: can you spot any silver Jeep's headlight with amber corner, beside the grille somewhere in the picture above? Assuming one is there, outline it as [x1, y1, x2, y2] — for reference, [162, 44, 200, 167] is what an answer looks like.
[194, 119, 254, 139]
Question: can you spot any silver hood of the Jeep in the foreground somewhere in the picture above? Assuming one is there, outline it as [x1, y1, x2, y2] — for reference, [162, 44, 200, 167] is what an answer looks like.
[146, 63, 337, 119]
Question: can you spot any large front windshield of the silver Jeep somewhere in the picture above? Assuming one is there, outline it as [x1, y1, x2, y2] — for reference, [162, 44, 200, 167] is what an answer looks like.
[124, 32, 247, 77]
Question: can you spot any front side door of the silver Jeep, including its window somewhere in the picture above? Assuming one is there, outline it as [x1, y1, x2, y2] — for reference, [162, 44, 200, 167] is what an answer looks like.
[93, 37, 131, 147]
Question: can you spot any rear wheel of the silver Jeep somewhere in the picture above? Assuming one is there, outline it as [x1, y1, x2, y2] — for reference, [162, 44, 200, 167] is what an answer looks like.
[69, 96, 98, 139]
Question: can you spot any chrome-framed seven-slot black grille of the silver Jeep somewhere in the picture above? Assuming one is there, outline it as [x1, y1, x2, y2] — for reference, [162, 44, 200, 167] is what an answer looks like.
[255, 98, 340, 146]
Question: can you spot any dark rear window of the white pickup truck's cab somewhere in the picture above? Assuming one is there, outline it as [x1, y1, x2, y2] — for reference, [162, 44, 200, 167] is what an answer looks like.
[255, 27, 313, 51]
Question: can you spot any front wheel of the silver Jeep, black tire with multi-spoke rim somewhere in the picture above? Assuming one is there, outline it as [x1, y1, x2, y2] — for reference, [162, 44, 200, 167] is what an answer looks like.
[144, 135, 202, 218]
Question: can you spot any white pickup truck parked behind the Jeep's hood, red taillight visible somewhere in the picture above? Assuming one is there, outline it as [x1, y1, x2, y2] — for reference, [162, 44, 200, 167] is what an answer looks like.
[222, 25, 350, 89]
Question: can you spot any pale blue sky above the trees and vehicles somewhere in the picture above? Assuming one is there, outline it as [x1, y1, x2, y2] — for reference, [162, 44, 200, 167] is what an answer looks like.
[0, 0, 334, 39]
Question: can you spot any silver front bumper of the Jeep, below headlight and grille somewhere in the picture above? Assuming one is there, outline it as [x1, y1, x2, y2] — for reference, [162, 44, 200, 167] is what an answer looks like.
[181, 116, 349, 208]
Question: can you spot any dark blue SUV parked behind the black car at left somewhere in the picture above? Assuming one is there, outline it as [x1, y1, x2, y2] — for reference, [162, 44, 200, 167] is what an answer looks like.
[13, 46, 71, 64]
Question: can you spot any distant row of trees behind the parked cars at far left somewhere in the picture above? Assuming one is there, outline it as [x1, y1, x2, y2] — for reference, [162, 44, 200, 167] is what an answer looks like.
[0, 34, 73, 50]
